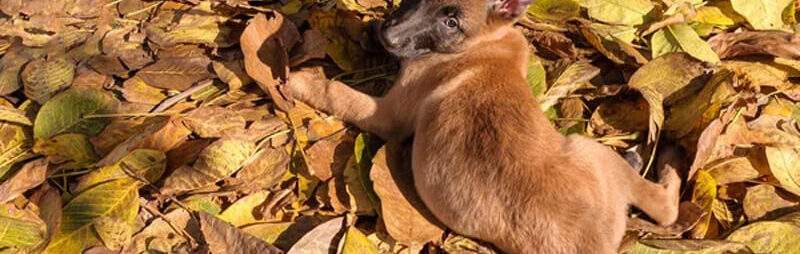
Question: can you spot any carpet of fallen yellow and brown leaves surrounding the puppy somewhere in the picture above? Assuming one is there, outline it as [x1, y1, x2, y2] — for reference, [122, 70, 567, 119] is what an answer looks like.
[0, 0, 800, 253]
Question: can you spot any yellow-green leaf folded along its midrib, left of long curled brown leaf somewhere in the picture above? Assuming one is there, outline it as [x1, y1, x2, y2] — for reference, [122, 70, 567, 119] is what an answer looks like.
[651, 24, 720, 63]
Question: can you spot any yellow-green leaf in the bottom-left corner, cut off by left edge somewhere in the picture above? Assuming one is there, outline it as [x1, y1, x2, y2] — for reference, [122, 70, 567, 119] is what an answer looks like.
[0, 203, 47, 249]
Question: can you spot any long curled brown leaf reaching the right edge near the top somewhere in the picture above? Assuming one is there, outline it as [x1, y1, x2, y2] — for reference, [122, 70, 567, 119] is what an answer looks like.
[708, 31, 800, 59]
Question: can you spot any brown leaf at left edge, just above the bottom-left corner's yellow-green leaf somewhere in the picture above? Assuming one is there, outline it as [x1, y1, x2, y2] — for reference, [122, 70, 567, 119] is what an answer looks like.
[0, 158, 47, 203]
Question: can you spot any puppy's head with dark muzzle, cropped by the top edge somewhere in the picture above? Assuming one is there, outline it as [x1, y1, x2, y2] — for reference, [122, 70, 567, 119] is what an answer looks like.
[377, 0, 535, 59]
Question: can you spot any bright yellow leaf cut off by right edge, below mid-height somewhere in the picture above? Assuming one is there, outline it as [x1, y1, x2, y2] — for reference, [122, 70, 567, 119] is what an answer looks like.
[766, 147, 800, 195]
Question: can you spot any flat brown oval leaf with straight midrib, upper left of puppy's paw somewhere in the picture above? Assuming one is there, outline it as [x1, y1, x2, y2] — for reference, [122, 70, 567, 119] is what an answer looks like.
[136, 57, 212, 91]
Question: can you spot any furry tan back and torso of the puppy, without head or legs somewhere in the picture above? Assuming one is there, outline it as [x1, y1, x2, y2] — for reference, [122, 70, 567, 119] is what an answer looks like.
[412, 24, 626, 253]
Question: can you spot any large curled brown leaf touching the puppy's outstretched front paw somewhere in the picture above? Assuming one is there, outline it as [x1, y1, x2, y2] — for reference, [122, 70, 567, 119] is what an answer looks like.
[240, 12, 300, 111]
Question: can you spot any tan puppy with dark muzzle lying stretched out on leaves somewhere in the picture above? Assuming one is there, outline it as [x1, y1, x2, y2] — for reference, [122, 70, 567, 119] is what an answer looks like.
[288, 0, 680, 254]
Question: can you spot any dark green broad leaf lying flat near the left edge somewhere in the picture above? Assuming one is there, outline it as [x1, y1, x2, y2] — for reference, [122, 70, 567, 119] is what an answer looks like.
[33, 87, 117, 139]
